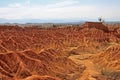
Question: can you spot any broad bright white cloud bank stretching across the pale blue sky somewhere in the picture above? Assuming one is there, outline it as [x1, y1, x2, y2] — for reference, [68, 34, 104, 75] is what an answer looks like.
[0, 0, 117, 19]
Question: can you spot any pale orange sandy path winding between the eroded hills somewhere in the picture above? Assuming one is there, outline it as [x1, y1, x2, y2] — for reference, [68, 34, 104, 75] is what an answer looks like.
[70, 55, 100, 80]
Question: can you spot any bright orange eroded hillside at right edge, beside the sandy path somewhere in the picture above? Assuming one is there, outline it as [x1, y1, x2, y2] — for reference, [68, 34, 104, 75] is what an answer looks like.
[94, 45, 120, 70]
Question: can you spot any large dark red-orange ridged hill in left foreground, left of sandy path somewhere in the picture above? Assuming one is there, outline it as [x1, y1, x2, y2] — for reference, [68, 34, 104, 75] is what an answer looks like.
[0, 49, 84, 80]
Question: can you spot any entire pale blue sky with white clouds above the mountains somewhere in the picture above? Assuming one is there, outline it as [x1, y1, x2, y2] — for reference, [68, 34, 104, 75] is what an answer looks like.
[0, 0, 120, 21]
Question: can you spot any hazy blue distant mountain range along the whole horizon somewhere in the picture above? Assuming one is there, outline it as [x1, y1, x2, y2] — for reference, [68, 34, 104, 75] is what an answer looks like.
[0, 18, 120, 24]
